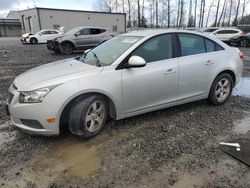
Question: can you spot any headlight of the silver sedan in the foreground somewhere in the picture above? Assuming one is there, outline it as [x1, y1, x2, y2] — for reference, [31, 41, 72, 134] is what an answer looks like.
[19, 85, 58, 103]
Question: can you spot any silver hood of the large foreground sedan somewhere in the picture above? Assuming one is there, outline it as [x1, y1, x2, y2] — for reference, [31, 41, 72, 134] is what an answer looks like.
[14, 58, 103, 91]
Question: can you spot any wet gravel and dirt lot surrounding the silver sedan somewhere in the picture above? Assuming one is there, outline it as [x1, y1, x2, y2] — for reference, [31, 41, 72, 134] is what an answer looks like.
[0, 38, 250, 188]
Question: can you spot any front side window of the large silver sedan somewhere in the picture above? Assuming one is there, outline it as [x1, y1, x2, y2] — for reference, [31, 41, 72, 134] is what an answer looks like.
[131, 34, 173, 63]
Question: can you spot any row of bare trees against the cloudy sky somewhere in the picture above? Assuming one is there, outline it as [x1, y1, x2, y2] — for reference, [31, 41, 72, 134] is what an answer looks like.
[94, 0, 250, 28]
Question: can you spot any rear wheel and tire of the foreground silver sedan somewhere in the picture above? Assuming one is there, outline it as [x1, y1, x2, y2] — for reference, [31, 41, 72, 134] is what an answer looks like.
[208, 73, 234, 105]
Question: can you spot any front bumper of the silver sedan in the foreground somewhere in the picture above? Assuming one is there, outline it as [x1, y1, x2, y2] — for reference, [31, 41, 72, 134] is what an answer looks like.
[6, 86, 60, 135]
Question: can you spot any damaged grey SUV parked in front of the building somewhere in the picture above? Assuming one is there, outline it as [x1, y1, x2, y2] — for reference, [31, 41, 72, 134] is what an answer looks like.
[47, 27, 112, 55]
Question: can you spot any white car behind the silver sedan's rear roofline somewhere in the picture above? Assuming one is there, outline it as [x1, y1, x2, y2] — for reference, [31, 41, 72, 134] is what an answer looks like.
[211, 28, 244, 42]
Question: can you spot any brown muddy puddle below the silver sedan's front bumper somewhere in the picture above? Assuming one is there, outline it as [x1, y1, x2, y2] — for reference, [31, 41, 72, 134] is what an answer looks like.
[0, 141, 102, 188]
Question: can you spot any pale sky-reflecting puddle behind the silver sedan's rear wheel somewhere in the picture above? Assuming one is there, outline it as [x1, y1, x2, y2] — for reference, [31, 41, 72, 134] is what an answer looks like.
[233, 77, 250, 97]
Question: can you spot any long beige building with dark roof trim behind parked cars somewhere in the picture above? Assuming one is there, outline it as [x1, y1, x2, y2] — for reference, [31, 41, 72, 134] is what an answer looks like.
[7, 7, 126, 34]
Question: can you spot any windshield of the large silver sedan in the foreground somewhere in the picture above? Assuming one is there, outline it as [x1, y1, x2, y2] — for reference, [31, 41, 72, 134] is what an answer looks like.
[81, 36, 142, 66]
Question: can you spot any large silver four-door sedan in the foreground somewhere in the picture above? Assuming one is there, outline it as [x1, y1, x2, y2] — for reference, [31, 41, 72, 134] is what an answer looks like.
[7, 30, 243, 138]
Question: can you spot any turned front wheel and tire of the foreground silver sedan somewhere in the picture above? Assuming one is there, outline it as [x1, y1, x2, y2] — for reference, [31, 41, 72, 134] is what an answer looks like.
[69, 95, 108, 139]
